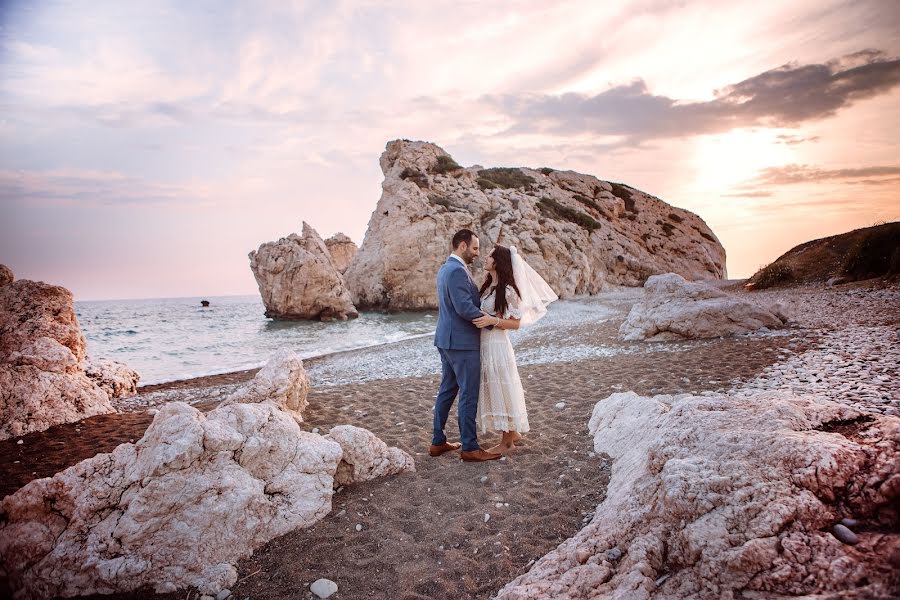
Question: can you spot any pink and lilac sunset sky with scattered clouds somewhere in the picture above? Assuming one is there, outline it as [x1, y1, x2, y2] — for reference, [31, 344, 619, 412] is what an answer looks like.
[0, 0, 900, 300]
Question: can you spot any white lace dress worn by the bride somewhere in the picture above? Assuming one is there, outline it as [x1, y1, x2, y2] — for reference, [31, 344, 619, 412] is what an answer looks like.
[476, 286, 529, 433]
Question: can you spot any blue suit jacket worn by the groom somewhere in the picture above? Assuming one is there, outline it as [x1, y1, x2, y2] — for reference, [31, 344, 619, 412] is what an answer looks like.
[434, 256, 481, 350]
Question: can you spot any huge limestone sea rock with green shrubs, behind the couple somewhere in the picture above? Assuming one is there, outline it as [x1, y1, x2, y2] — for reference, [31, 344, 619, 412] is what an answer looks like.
[346, 140, 725, 310]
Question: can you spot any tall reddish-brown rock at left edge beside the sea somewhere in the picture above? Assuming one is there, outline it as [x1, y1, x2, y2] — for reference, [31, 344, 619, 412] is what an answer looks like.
[0, 279, 115, 439]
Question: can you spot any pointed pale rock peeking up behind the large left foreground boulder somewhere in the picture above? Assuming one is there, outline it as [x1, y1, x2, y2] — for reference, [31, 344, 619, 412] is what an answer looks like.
[220, 349, 309, 423]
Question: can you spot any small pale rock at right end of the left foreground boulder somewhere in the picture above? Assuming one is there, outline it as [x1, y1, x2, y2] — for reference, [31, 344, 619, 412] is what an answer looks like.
[325, 425, 416, 485]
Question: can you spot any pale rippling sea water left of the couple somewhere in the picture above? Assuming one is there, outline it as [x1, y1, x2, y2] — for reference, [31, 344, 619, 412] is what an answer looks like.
[75, 295, 437, 385]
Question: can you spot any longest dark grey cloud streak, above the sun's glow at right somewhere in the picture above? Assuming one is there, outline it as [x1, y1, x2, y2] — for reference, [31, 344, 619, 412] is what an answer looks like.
[483, 50, 900, 145]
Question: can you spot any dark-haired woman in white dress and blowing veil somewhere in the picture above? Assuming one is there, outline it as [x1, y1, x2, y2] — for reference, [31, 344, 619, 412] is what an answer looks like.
[473, 244, 558, 454]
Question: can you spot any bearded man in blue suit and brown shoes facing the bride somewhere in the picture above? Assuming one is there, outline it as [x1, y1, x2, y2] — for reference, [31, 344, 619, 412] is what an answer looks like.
[428, 229, 500, 462]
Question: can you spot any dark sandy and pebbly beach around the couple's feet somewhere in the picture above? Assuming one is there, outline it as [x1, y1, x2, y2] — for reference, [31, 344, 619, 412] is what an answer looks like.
[0, 284, 900, 599]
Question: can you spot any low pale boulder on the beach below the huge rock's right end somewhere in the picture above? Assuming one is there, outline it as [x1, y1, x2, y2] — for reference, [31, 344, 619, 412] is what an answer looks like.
[619, 273, 784, 341]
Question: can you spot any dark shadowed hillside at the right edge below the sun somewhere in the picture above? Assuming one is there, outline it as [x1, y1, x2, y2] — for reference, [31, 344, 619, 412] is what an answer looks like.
[747, 222, 900, 289]
